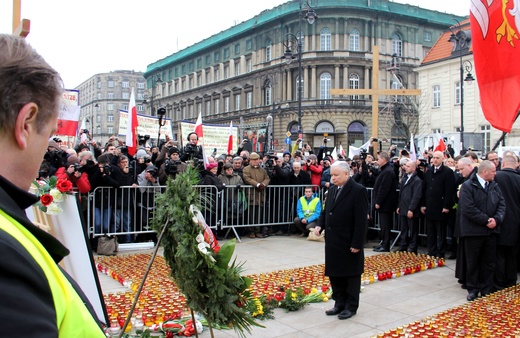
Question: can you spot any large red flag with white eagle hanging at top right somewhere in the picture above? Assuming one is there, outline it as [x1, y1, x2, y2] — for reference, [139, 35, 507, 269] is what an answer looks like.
[470, 0, 520, 132]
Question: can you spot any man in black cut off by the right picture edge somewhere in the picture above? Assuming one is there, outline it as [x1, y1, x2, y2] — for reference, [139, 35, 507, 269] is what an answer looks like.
[493, 155, 520, 290]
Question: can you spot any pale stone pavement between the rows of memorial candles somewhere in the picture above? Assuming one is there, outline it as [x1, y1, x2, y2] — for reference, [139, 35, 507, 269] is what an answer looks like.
[100, 235, 467, 338]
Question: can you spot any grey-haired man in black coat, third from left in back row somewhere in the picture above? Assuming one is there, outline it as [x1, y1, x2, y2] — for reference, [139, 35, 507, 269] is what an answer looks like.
[421, 151, 455, 258]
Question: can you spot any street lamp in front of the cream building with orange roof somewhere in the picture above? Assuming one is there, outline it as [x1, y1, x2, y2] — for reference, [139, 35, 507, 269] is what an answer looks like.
[448, 19, 475, 150]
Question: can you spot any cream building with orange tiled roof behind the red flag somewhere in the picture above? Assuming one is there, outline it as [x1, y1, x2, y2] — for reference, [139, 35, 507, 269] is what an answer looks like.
[416, 20, 520, 154]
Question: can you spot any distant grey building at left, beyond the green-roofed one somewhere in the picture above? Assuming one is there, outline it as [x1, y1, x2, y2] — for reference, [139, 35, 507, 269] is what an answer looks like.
[74, 70, 147, 145]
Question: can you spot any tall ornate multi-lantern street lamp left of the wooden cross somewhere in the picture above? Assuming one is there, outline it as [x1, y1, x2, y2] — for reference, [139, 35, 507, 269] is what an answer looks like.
[282, 0, 318, 144]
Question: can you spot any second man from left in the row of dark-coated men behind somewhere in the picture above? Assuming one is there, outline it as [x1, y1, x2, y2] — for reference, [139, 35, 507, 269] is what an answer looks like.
[397, 161, 422, 253]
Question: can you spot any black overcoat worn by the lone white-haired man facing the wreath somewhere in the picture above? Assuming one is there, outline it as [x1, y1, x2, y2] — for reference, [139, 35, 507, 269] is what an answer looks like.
[318, 178, 368, 277]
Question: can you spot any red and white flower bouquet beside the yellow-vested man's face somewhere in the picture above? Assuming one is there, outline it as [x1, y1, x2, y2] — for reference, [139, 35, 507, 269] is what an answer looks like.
[32, 176, 72, 215]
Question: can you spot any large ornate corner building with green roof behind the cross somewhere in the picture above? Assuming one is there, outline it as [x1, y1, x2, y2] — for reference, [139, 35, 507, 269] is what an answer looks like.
[144, 0, 463, 151]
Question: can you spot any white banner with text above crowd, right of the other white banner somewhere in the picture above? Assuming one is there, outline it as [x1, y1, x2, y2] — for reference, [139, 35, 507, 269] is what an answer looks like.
[178, 121, 239, 156]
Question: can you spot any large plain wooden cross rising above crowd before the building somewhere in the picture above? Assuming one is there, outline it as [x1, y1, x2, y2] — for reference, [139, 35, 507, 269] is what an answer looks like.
[330, 46, 421, 153]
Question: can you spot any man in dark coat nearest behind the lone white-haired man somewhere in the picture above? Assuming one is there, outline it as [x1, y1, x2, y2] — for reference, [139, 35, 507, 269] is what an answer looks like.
[372, 152, 397, 252]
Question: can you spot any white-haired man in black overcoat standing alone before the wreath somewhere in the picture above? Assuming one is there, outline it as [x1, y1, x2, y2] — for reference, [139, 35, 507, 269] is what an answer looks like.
[314, 161, 368, 319]
